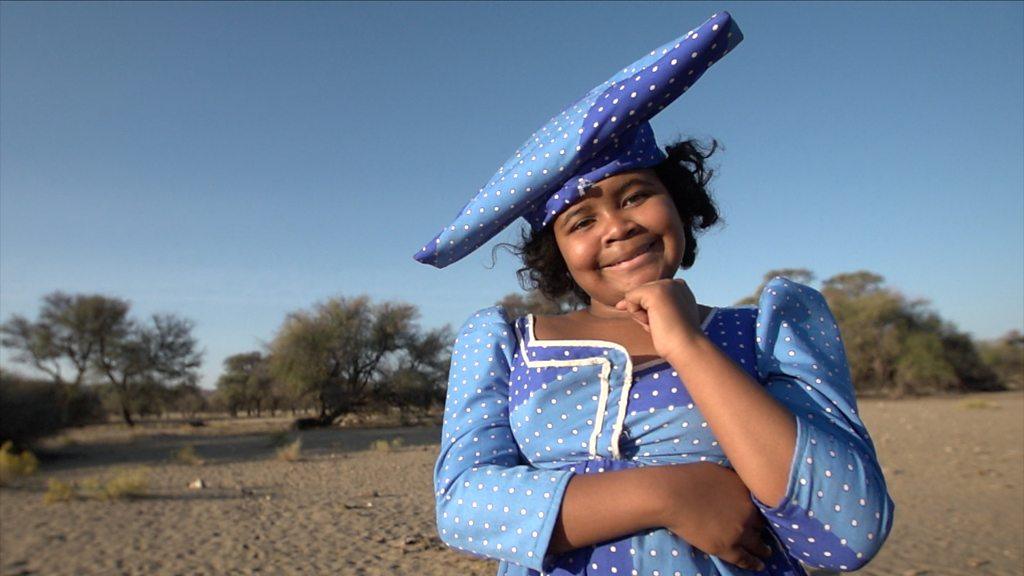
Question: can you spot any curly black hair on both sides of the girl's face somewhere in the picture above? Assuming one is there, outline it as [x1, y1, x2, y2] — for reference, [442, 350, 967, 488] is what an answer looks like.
[504, 138, 720, 304]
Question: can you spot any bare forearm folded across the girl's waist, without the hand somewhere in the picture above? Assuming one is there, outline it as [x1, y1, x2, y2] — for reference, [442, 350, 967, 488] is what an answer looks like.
[548, 463, 717, 553]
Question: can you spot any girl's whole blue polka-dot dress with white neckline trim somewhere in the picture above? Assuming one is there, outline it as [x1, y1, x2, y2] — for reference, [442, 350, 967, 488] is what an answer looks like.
[434, 278, 894, 576]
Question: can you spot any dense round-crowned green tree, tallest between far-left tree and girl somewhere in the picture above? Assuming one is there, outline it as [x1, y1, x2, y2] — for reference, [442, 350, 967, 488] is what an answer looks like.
[270, 296, 418, 424]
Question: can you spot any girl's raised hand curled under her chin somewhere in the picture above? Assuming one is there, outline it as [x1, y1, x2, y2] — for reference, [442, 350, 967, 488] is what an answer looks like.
[615, 279, 700, 358]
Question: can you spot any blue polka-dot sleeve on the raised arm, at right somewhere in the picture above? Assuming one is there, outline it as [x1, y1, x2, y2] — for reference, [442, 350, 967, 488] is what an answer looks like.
[754, 278, 894, 571]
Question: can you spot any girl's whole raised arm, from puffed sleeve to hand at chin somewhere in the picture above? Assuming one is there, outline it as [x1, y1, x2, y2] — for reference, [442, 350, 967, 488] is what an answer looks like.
[618, 278, 894, 571]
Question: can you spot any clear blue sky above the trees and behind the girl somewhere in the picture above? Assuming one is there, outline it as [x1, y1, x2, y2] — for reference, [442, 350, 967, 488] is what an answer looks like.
[0, 2, 1024, 386]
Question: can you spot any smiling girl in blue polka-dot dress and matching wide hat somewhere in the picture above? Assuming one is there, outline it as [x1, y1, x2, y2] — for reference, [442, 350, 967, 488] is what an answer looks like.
[417, 12, 893, 576]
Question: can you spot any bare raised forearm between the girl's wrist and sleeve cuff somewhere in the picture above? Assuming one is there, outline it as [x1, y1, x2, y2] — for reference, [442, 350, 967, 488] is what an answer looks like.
[668, 336, 797, 505]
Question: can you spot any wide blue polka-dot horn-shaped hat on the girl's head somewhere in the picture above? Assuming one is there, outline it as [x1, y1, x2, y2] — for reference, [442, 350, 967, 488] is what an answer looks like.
[415, 12, 743, 268]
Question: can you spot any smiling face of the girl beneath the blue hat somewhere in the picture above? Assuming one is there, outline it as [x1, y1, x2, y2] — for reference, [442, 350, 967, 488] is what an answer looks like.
[553, 170, 686, 306]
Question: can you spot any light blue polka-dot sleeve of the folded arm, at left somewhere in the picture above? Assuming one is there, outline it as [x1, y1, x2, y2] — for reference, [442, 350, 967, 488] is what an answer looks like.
[434, 306, 572, 572]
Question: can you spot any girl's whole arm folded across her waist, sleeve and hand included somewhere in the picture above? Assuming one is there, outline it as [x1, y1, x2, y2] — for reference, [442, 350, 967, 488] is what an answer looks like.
[434, 307, 770, 571]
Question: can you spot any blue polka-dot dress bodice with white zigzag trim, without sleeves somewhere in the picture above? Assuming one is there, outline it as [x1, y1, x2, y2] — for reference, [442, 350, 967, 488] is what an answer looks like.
[509, 307, 758, 467]
